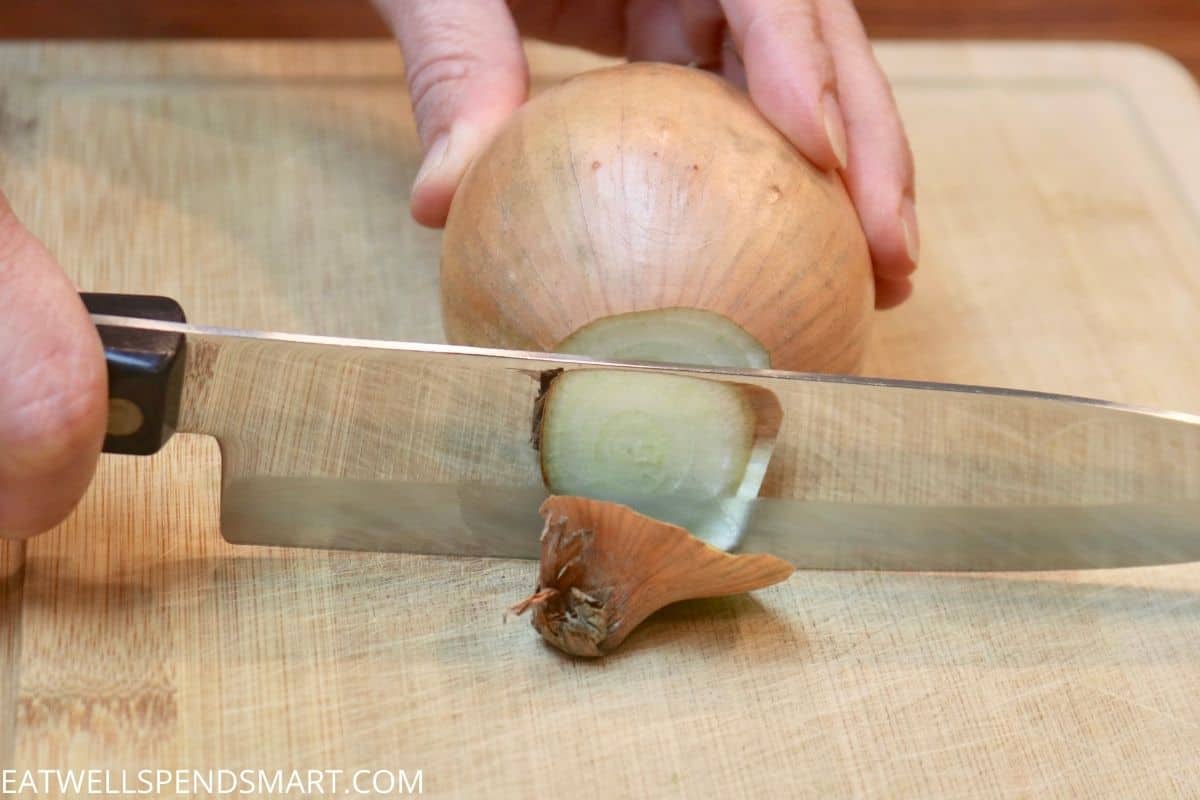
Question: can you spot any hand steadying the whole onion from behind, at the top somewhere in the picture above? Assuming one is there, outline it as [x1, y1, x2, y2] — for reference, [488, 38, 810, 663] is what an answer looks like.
[376, 0, 919, 308]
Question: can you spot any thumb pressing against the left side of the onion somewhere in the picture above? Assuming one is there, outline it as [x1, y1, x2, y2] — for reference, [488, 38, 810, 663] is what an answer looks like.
[377, 0, 529, 227]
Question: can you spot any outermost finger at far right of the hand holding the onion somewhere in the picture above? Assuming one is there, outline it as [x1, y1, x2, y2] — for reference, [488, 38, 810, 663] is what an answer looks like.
[821, 0, 920, 279]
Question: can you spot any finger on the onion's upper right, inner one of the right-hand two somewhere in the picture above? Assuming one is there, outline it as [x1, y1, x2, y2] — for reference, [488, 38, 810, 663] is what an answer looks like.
[721, 0, 846, 169]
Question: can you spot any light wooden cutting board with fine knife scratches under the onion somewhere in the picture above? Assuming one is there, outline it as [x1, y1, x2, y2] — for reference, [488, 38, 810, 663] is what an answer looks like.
[0, 42, 1200, 798]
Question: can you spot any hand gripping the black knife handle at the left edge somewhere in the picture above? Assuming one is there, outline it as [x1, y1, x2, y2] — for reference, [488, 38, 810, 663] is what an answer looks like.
[0, 190, 108, 539]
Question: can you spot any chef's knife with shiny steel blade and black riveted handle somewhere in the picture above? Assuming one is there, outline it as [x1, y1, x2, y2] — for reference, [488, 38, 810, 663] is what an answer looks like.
[84, 294, 1200, 571]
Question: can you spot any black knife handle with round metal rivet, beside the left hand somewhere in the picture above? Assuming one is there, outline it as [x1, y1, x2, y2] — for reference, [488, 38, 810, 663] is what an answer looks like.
[80, 291, 187, 456]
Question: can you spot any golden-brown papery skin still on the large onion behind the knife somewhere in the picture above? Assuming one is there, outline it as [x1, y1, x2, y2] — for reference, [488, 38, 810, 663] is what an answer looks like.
[440, 64, 875, 373]
